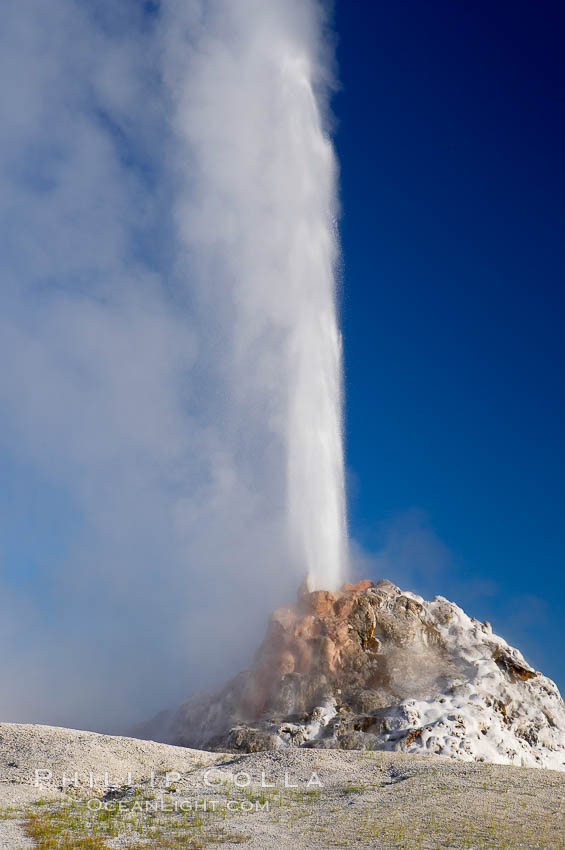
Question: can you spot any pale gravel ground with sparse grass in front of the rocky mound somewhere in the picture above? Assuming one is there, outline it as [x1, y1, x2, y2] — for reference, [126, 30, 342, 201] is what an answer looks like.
[0, 723, 565, 850]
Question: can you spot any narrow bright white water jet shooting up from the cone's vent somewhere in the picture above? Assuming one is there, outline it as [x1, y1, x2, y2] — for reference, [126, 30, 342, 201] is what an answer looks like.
[282, 49, 347, 590]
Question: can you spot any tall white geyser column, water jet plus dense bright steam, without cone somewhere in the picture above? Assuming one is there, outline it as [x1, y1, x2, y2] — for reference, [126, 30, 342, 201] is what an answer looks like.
[162, 0, 347, 589]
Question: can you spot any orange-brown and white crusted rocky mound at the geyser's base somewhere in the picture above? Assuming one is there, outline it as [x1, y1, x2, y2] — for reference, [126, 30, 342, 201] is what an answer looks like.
[144, 579, 565, 770]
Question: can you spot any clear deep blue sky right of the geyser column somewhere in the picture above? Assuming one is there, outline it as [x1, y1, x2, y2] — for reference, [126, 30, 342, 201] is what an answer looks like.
[334, 0, 565, 689]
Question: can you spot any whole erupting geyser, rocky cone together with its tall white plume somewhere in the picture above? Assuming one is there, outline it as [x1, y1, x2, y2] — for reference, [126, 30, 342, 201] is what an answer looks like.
[145, 0, 565, 770]
